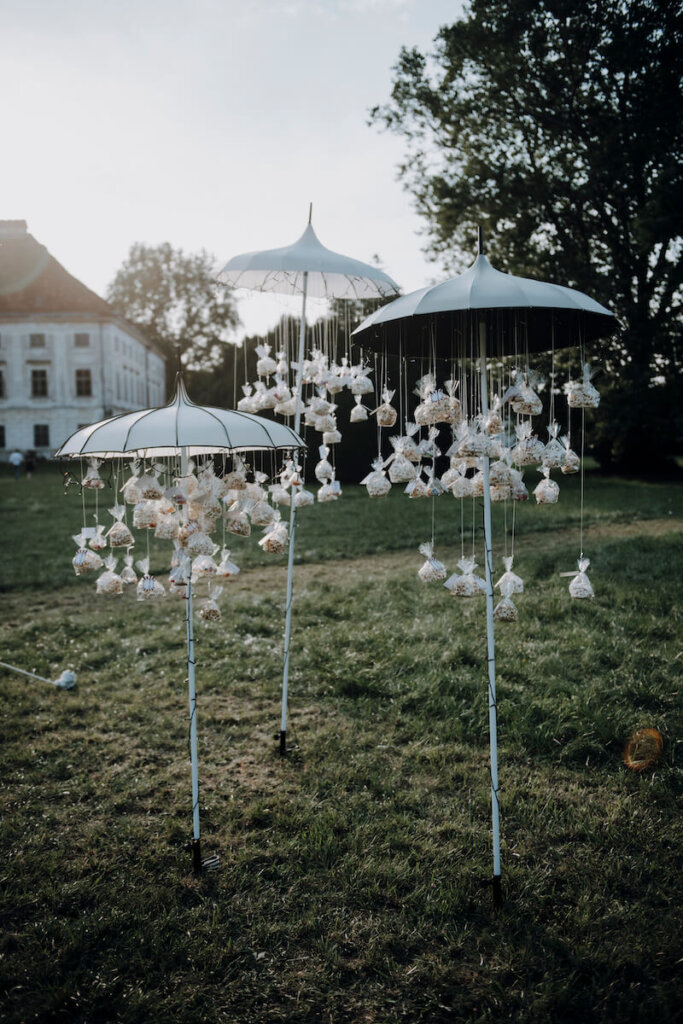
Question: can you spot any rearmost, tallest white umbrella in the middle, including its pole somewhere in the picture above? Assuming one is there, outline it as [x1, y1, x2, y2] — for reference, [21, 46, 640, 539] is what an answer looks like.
[217, 207, 399, 755]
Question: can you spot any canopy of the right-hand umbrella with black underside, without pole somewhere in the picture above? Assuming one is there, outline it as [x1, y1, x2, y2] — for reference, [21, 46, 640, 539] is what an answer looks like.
[353, 253, 616, 355]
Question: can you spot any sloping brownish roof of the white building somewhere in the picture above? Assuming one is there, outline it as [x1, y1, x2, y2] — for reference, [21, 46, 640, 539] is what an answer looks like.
[0, 220, 166, 358]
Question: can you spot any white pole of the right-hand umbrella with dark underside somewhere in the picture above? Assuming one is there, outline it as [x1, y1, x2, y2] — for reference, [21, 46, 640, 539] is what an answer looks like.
[479, 321, 503, 906]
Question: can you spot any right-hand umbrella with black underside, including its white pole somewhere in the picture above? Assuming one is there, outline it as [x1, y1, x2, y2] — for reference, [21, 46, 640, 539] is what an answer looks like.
[353, 229, 616, 905]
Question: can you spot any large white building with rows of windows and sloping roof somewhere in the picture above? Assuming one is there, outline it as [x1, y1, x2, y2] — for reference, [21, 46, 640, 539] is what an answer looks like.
[0, 221, 166, 460]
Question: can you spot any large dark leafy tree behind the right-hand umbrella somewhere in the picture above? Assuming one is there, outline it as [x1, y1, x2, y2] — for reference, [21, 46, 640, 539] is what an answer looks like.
[371, 0, 683, 468]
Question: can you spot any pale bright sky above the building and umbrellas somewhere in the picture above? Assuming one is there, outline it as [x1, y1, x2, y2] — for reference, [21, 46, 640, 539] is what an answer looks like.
[0, 0, 463, 336]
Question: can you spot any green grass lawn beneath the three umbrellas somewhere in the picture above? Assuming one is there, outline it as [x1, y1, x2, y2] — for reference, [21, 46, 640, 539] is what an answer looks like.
[0, 472, 683, 1024]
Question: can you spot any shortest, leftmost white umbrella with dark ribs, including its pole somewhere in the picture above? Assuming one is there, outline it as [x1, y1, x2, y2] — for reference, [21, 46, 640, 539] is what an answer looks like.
[54, 374, 305, 873]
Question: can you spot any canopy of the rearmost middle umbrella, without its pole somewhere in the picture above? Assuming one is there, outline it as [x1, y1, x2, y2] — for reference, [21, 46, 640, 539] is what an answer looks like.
[217, 216, 399, 299]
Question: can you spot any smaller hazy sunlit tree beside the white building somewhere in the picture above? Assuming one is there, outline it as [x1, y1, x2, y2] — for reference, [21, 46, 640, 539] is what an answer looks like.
[106, 242, 240, 395]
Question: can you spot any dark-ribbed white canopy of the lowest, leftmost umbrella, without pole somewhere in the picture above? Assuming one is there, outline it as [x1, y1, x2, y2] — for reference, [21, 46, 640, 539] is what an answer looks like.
[54, 374, 305, 459]
